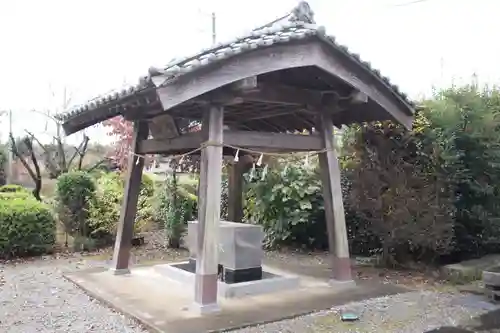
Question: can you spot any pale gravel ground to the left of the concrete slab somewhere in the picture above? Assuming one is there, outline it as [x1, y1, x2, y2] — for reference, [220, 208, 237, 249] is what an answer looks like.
[0, 259, 147, 333]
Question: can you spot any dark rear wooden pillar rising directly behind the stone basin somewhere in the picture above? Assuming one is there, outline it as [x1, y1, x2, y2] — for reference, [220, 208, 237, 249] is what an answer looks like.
[227, 155, 252, 222]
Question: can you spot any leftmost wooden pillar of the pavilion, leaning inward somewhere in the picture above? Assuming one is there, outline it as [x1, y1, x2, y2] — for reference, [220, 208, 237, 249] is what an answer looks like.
[111, 121, 149, 274]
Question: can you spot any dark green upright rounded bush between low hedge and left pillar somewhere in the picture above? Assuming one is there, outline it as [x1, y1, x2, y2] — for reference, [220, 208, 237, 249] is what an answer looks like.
[56, 171, 95, 236]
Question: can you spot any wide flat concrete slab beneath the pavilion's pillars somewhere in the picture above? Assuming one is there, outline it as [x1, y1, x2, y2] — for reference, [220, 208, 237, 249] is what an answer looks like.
[65, 266, 408, 333]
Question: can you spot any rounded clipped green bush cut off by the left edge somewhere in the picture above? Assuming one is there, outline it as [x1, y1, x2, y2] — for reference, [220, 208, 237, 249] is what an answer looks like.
[0, 197, 56, 258]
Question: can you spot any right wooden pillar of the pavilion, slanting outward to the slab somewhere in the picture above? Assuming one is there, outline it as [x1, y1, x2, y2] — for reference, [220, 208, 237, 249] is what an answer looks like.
[317, 113, 352, 281]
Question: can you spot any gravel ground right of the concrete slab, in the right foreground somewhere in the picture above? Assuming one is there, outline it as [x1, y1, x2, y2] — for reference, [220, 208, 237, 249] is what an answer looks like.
[234, 291, 500, 333]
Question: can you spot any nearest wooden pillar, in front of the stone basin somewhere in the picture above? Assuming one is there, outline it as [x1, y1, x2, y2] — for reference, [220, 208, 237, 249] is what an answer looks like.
[194, 106, 224, 313]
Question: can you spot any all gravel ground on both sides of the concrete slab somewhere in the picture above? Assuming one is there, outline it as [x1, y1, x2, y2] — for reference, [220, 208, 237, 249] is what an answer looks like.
[0, 253, 500, 333]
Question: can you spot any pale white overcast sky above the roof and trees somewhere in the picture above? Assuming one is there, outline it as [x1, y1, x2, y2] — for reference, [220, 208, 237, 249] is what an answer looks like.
[0, 0, 500, 144]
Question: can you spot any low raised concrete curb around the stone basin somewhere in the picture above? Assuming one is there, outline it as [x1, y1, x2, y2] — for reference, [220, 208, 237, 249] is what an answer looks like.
[155, 261, 300, 298]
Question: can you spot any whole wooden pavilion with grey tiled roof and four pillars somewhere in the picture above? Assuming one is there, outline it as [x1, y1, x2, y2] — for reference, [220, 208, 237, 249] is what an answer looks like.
[55, 2, 414, 307]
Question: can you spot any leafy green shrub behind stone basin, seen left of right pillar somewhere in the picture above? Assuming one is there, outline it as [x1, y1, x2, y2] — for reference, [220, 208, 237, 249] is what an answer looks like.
[245, 163, 328, 248]
